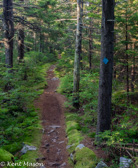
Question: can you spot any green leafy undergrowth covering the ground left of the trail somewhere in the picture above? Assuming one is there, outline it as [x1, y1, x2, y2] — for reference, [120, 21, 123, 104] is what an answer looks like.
[0, 53, 50, 167]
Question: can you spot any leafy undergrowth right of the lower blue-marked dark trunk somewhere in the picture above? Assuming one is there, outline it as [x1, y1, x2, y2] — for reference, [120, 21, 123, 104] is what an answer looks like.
[101, 90, 138, 146]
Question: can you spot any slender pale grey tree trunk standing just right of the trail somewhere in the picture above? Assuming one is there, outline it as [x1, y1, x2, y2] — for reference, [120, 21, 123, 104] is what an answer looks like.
[73, 0, 82, 109]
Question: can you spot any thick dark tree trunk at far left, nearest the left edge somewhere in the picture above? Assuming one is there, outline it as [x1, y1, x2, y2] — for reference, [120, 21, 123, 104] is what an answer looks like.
[3, 0, 14, 68]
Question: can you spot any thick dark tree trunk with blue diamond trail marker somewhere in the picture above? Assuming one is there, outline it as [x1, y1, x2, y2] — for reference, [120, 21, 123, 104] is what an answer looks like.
[97, 0, 114, 134]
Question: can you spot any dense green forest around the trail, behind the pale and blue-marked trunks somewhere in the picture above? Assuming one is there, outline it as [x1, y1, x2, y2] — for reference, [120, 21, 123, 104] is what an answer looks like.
[0, 0, 138, 167]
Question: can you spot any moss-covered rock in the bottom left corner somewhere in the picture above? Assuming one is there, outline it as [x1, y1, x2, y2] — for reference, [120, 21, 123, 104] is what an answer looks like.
[0, 148, 14, 162]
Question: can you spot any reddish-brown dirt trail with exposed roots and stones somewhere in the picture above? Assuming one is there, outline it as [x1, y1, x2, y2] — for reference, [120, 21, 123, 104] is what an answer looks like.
[36, 65, 70, 168]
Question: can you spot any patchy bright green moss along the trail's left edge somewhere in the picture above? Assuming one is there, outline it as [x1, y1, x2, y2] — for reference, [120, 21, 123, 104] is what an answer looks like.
[12, 64, 51, 168]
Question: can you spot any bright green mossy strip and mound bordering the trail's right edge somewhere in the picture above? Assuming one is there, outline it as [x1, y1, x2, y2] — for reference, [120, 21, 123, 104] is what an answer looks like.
[66, 113, 97, 168]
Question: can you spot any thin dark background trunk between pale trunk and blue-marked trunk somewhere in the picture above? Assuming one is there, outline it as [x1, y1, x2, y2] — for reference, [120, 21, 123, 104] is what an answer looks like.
[89, 18, 92, 69]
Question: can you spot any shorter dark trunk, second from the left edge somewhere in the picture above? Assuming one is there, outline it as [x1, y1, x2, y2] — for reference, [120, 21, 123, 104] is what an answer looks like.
[18, 17, 24, 62]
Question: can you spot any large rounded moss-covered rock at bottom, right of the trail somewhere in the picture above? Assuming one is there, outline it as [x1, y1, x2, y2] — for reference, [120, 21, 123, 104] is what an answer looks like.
[74, 147, 97, 168]
